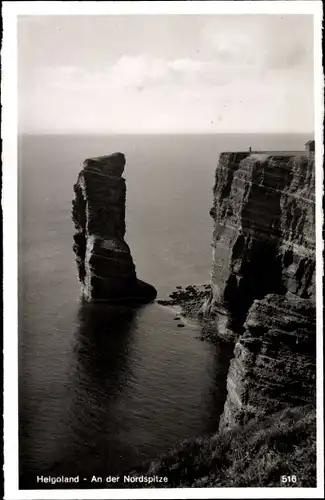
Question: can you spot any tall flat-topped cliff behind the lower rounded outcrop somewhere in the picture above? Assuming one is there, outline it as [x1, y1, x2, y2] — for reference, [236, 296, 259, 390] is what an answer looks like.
[202, 153, 315, 337]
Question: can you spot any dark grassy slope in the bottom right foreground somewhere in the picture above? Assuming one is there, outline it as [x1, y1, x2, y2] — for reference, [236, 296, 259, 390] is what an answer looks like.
[128, 406, 316, 488]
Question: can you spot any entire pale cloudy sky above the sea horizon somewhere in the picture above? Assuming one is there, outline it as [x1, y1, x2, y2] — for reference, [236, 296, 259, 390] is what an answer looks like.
[18, 14, 314, 134]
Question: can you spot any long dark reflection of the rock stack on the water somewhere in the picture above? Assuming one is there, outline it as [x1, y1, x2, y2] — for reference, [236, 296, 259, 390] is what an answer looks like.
[56, 303, 139, 476]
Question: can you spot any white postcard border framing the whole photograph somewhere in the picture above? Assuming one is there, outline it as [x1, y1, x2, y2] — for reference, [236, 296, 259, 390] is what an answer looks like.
[1, 0, 324, 500]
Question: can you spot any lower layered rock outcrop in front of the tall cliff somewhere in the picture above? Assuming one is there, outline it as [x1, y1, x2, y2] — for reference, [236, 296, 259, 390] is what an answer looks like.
[220, 292, 316, 429]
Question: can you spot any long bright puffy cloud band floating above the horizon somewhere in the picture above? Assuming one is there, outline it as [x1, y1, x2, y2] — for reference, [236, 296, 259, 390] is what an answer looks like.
[28, 55, 245, 92]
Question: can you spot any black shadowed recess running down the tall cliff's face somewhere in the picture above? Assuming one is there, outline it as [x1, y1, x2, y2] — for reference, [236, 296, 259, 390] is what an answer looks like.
[224, 158, 292, 325]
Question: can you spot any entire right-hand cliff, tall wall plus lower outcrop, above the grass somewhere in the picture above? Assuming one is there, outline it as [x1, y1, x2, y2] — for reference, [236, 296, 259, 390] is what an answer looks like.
[202, 148, 316, 428]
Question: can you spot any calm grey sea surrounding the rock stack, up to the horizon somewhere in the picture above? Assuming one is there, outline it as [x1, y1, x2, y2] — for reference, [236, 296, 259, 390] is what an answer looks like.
[19, 135, 309, 488]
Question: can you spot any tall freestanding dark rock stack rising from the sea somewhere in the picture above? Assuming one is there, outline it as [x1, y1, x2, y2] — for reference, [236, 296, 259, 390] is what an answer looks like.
[72, 153, 157, 303]
